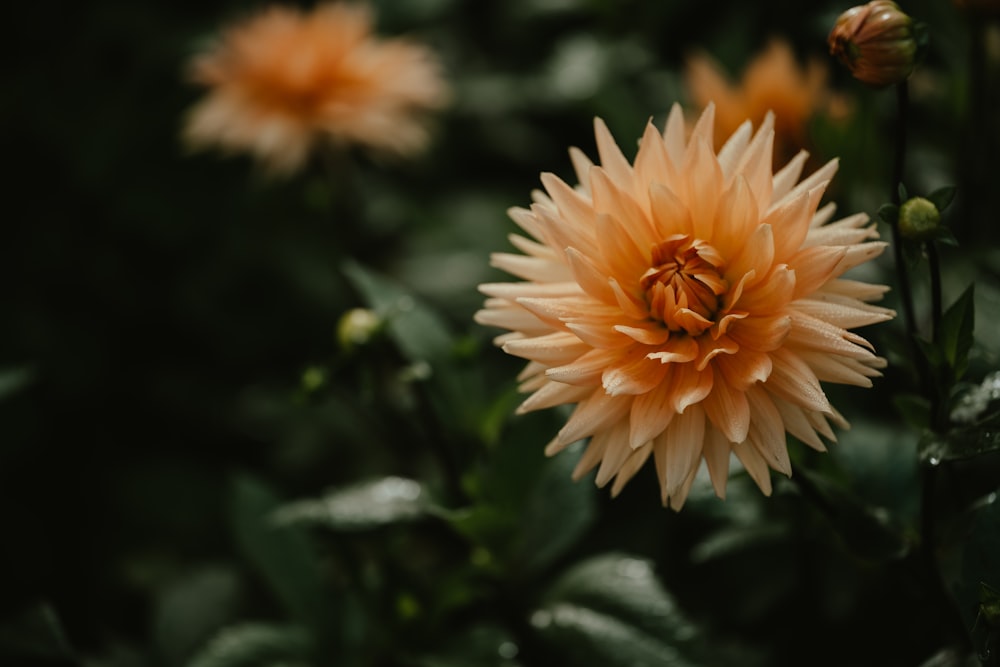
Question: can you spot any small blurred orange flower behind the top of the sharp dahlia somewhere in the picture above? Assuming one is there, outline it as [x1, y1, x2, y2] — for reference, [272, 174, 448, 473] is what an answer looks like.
[685, 39, 846, 164]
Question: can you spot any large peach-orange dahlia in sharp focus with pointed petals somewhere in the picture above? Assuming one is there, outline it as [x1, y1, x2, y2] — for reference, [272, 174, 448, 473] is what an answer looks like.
[476, 105, 894, 509]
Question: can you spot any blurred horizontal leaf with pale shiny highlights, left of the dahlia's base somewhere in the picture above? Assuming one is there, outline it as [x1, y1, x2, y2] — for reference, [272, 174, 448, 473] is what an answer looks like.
[271, 477, 430, 531]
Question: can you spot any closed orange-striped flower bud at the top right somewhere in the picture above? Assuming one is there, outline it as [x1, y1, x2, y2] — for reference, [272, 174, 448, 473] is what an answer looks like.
[827, 0, 917, 88]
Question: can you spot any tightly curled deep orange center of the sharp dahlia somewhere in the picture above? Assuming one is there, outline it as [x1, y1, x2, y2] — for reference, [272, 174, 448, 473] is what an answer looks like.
[639, 234, 729, 336]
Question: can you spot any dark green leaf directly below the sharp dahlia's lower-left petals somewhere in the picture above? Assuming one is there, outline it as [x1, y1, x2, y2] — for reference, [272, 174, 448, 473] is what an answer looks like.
[512, 444, 597, 573]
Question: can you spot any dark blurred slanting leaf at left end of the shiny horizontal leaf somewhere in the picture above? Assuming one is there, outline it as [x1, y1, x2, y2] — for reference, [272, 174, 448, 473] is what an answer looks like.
[230, 475, 332, 634]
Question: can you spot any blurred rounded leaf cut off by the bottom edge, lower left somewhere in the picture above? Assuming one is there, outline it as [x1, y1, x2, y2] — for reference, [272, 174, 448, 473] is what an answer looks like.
[188, 623, 313, 667]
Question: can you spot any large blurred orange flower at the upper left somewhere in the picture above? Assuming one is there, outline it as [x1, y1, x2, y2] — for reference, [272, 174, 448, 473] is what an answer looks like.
[184, 3, 447, 173]
